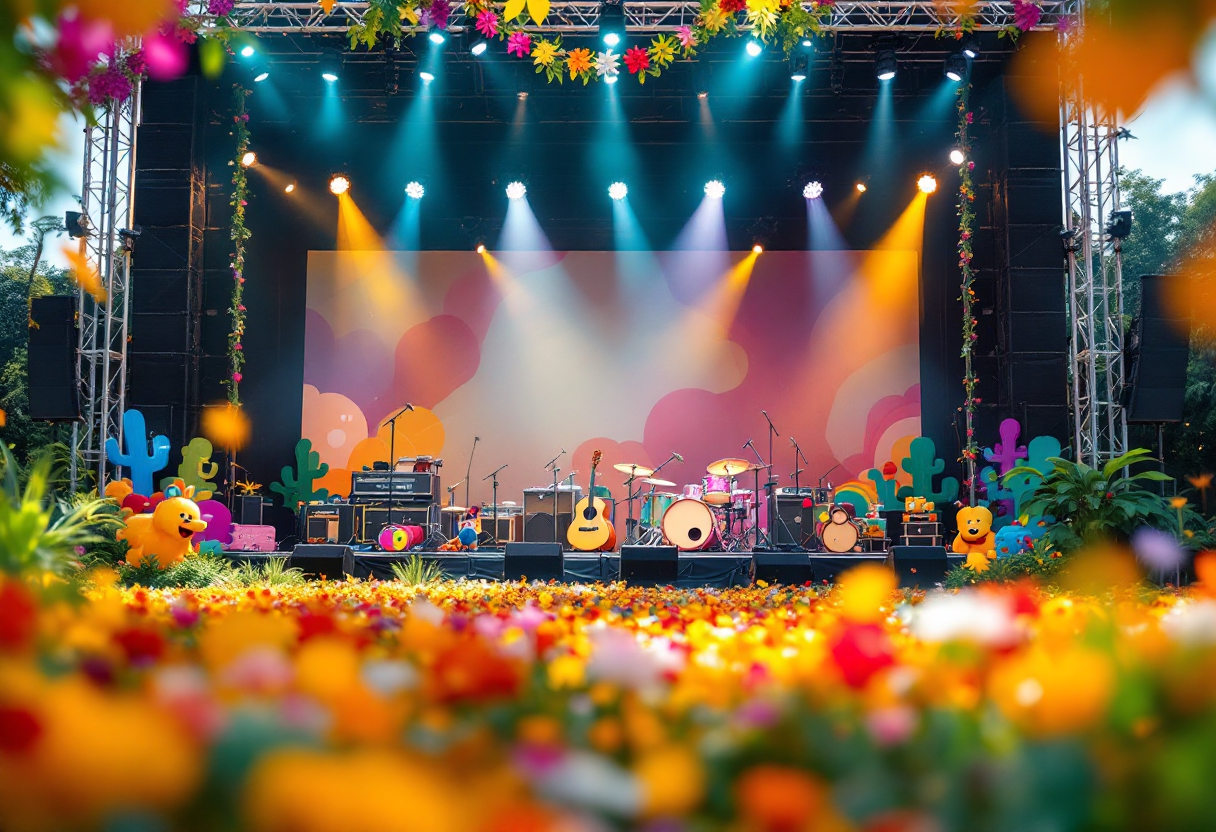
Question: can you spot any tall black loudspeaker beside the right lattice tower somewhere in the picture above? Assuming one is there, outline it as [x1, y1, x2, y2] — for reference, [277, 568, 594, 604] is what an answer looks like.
[1122, 276, 1190, 425]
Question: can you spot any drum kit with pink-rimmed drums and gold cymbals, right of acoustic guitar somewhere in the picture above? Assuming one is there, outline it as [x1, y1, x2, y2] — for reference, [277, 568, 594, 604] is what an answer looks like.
[613, 459, 766, 552]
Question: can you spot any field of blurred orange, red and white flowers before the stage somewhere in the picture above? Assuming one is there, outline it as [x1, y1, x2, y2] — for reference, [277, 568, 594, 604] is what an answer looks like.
[0, 564, 1216, 832]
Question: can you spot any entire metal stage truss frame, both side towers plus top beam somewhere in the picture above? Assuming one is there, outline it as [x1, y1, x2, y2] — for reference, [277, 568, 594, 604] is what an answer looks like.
[83, 0, 1127, 488]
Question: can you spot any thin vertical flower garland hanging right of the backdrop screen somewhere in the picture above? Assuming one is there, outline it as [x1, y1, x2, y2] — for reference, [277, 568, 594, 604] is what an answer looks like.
[958, 83, 980, 489]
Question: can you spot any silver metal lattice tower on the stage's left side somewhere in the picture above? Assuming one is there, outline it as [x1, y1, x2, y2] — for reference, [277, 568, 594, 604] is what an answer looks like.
[71, 85, 140, 491]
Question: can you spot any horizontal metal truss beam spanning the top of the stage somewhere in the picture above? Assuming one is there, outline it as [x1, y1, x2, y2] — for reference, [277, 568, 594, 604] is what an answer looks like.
[214, 0, 1076, 34]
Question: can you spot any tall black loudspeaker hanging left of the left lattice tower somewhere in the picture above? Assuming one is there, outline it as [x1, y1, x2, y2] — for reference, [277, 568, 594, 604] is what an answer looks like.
[28, 296, 80, 422]
